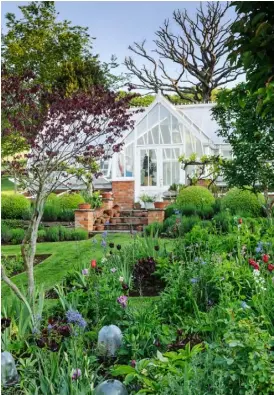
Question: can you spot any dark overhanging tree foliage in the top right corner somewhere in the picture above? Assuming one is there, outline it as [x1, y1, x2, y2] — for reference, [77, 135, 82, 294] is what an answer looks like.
[228, 1, 274, 116]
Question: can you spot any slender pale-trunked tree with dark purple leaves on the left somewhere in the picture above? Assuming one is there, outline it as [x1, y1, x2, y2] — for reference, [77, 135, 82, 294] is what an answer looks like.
[2, 71, 139, 297]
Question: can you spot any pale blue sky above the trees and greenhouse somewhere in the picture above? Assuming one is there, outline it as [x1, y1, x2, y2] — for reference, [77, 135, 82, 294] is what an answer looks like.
[1, 1, 244, 89]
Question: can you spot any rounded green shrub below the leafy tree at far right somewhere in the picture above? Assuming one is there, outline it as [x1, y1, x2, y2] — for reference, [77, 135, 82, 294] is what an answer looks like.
[222, 188, 264, 217]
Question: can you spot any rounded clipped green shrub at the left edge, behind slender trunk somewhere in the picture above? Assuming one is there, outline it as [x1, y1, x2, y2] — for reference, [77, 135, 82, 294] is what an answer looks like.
[1, 194, 30, 219]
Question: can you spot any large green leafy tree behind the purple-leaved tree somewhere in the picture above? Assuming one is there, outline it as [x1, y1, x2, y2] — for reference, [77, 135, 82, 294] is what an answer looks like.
[2, 1, 123, 95]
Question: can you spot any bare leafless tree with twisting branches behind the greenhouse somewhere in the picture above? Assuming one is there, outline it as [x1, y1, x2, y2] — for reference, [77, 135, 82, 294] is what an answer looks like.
[125, 2, 241, 102]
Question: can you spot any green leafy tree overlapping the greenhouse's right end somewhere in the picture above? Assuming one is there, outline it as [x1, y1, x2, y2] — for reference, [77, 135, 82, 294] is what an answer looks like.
[212, 84, 274, 216]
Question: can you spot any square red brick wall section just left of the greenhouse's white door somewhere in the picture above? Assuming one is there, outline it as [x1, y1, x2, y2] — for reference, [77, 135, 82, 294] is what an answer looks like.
[112, 181, 134, 210]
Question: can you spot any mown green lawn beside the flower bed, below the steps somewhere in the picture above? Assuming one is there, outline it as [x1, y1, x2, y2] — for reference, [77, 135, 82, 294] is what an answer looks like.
[2, 233, 131, 297]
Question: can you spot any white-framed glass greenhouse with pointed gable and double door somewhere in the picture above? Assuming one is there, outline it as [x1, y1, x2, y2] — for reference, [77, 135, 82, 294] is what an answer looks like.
[101, 95, 231, 201]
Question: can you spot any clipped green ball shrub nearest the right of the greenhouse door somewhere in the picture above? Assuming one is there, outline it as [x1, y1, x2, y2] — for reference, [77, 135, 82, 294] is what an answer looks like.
[176, 186, 215, 209]
